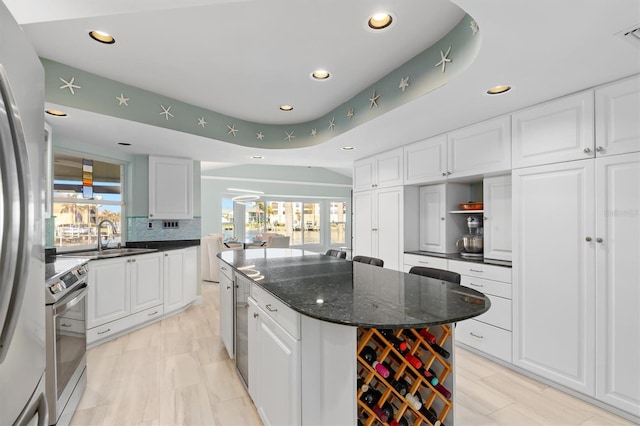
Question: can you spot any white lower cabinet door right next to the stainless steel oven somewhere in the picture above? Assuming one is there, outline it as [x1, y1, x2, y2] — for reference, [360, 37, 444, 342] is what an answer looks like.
[87, 258, 131, 328]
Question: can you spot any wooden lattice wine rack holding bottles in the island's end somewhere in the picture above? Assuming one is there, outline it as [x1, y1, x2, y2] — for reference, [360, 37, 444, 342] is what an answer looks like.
[358, 325, 453, 426]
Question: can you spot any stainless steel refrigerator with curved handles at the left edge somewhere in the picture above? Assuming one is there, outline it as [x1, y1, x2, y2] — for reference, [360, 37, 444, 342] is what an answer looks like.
[0, 1, 47, 426]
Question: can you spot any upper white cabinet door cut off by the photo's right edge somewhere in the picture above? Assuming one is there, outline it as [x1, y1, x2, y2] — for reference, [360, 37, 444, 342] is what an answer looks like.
[596, 75, 640, 155]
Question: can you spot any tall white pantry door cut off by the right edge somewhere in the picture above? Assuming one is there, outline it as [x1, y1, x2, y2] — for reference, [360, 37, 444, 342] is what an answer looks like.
[588, 154, 640, 416]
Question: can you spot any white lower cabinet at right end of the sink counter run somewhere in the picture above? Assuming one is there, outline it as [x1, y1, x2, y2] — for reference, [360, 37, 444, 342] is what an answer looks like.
[163, 247, 197, 312]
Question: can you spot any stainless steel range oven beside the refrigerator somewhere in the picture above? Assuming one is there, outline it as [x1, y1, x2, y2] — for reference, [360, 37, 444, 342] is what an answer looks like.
[45, 258, 87, 425]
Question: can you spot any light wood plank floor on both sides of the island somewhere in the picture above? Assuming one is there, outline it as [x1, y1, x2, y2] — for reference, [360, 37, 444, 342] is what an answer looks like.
[71, 282, 634, 426]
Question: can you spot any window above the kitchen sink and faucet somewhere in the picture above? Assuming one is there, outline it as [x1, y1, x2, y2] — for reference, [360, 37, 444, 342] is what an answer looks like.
[53, 153, 124, 248]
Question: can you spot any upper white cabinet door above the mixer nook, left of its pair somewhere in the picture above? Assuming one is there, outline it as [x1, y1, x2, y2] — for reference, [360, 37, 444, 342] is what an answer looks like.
[404, 135, 447, 185]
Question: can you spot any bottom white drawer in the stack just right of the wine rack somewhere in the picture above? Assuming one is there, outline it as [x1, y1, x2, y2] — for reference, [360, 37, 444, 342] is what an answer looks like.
[455, 319, 512, 362]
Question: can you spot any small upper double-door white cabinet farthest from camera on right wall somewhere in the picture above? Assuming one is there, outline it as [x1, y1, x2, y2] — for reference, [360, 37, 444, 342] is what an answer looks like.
[353, 148, 403, 191]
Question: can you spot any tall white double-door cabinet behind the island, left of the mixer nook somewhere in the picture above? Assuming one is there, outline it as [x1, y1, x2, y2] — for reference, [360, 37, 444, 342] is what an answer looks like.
[353, 187, 404, 270]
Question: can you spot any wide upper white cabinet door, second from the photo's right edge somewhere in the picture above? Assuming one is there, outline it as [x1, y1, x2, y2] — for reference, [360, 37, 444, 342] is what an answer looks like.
[512, 90, 595, 169]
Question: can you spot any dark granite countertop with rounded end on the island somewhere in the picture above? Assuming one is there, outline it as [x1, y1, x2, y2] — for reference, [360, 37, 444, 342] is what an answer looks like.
[218, 248, 491, 328]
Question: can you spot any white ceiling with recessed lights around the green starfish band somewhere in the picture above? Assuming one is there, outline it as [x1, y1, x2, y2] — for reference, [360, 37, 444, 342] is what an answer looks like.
[4, 0, 640, 174]
